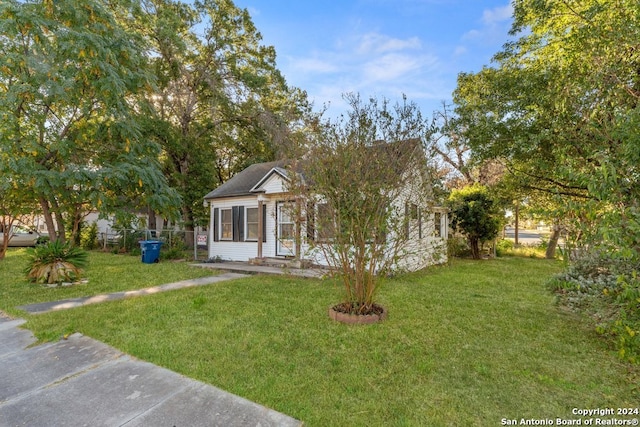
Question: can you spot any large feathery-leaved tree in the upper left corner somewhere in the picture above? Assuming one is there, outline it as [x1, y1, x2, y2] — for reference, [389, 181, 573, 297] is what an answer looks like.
[0, 0, 179, 244]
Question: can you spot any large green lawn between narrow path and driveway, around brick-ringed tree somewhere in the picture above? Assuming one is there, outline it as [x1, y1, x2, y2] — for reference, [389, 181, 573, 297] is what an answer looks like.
[0, 252, 640, 426]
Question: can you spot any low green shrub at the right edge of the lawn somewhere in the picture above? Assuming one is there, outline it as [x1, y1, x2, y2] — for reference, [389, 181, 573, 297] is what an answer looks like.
[547, 251, 640, 363]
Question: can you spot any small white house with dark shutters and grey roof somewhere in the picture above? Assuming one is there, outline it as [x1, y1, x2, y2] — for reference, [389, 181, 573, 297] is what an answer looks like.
[204, 155, 448, 270]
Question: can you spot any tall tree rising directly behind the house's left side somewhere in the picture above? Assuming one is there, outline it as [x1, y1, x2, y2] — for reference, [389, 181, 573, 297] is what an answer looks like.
[142, 0, 307, 247]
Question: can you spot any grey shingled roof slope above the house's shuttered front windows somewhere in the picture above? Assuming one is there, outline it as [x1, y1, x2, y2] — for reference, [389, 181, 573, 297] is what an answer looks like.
[204, 160, 286, 199]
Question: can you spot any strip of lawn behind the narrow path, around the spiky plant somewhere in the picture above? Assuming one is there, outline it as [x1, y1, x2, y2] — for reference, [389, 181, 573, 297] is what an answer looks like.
[0, 249, 214, 316]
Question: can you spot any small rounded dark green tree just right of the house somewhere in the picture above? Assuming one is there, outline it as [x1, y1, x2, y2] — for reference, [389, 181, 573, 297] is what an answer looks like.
[447, 184, 501, 259]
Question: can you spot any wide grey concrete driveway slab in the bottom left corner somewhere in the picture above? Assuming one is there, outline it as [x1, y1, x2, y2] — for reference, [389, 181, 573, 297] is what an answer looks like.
[0, 314, 302, 427]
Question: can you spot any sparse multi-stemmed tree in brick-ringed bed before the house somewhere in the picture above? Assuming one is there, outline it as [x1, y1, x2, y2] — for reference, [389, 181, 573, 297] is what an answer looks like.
[290, 95, 430, 320]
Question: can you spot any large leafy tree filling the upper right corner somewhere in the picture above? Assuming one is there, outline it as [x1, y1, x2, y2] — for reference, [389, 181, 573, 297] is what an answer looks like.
[455, 0, 640, 255]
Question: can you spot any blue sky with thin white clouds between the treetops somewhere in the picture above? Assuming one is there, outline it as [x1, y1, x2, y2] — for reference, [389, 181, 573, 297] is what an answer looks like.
[235, 0, 512, 117]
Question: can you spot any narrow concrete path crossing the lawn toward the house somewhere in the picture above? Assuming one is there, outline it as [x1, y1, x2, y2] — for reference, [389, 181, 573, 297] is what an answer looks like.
[17, 273, 247, 314]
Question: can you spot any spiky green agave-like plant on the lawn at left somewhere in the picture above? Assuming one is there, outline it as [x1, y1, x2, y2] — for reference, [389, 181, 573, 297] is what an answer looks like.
[25, 241, 87, 284]
